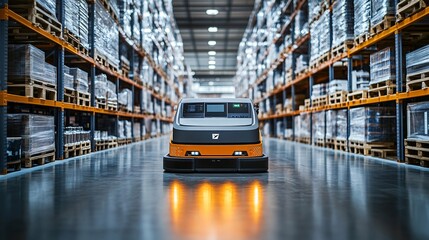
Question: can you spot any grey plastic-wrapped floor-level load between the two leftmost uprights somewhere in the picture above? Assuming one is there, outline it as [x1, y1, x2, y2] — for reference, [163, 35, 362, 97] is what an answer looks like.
[7, 114, 55, 158]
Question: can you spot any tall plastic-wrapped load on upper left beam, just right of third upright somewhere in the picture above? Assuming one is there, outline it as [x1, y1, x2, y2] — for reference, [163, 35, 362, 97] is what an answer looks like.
[94, 1, 119, 66]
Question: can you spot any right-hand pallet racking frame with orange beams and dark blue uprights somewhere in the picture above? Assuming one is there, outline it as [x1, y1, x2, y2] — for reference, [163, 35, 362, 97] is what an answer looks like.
[237, 0, 429, 162]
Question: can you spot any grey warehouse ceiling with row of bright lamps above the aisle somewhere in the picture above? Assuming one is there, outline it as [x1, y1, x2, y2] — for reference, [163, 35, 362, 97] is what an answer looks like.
[173, 0, 254, 86]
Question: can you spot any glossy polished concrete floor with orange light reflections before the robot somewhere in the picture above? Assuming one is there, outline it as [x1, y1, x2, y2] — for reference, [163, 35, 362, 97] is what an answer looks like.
[0, 137, 429, 240]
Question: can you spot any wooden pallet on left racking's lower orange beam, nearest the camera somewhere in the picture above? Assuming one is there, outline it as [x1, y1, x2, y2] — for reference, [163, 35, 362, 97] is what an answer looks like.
[7, 78, 57, 101]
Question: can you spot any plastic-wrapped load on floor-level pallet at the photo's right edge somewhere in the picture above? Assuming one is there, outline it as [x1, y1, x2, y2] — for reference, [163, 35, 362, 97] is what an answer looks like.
[407, 102, 429, 141]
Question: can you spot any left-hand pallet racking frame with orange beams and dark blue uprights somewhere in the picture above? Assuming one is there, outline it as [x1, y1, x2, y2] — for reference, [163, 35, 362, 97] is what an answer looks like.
[0, 0, 184, 174]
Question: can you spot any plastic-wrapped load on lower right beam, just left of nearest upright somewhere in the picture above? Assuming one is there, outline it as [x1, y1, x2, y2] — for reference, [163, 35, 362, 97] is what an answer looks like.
[370, 48, 396, 84]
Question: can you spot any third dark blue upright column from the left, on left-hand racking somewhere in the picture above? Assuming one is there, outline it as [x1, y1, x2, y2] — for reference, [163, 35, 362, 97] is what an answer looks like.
[88, 1, 94, 152]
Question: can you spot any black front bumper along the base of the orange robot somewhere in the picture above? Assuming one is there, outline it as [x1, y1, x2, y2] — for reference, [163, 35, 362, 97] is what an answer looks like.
[163, 154, 268, 172]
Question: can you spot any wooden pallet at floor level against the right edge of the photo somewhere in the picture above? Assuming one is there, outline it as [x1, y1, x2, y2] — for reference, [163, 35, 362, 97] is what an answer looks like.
[404, 139, 429, 167]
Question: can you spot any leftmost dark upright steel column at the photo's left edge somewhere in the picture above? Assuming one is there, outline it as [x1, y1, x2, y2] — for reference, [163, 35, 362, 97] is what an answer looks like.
[0, 0, 8, 174]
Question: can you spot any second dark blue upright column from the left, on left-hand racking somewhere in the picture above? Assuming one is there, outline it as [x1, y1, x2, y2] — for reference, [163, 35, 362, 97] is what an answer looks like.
[55, 0, 65, 159]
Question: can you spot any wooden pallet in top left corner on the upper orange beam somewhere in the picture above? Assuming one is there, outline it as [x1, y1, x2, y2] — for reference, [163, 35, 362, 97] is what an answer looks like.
[9, 0, 62, 38]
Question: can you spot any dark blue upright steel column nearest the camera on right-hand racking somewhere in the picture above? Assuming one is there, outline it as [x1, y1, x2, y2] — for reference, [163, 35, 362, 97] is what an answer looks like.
[395, 33, 405, 162]
